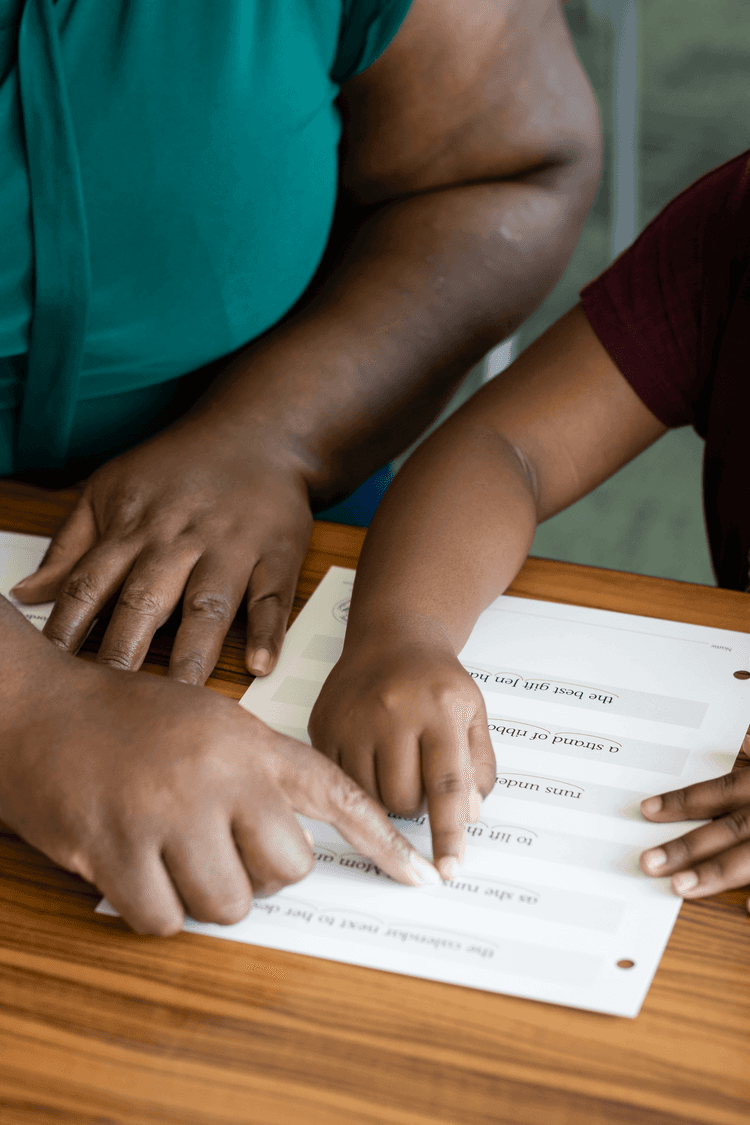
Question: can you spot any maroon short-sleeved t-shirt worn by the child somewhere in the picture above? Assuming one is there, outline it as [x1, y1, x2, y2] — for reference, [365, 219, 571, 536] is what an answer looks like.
[581, 152, 750, 590]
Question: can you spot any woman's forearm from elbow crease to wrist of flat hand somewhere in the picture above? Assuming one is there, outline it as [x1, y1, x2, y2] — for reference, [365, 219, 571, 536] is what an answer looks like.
[183, 169, 582, 502]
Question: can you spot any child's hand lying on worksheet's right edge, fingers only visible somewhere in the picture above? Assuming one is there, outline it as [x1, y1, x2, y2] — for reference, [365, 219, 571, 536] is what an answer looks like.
[641, 768, 750, 910]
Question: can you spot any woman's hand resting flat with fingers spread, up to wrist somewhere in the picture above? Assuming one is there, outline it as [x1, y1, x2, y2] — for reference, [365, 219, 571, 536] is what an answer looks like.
[13, 415, 311, 684]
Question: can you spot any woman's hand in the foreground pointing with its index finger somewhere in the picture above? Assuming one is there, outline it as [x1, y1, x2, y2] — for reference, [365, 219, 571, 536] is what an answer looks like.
[0, 608, 440, 935]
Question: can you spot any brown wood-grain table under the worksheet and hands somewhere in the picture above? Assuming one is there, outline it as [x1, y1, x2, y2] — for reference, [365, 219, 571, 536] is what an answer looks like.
[0, 484, 750, 1125]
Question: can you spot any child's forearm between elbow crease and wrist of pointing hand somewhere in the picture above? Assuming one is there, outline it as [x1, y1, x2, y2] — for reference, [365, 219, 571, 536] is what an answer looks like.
[346, 420, 536, 654]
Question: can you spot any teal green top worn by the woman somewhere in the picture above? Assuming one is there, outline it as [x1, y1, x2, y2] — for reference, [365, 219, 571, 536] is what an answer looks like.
[0, 0, 410, 476]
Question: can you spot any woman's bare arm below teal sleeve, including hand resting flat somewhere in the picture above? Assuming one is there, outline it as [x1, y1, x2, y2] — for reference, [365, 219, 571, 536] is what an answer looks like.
[13, 0, 600, 683]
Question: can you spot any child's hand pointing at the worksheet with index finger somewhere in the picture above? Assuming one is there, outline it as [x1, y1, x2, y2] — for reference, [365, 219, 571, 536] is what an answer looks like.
[309, 642, 495, 879]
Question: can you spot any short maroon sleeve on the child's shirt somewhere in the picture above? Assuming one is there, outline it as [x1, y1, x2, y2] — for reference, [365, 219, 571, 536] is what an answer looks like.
[580, 152, 750, 435]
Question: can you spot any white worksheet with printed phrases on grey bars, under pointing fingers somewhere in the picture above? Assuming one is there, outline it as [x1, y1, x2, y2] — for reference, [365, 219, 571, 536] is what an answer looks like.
[100, 567, 750, 1017]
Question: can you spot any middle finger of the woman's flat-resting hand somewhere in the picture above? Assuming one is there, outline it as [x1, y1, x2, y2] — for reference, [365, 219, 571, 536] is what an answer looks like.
[97, 543, 205, 672]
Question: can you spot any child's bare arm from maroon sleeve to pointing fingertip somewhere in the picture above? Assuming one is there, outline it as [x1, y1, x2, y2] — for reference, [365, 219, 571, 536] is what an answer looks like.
[310, 307, 666, 878]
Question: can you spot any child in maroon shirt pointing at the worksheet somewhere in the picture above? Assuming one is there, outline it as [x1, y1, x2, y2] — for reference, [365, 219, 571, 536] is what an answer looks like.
[310, 153, 750, 908]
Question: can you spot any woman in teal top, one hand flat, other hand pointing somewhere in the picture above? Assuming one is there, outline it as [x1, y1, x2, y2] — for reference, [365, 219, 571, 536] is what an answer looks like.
[0, 0, 598, 932]
